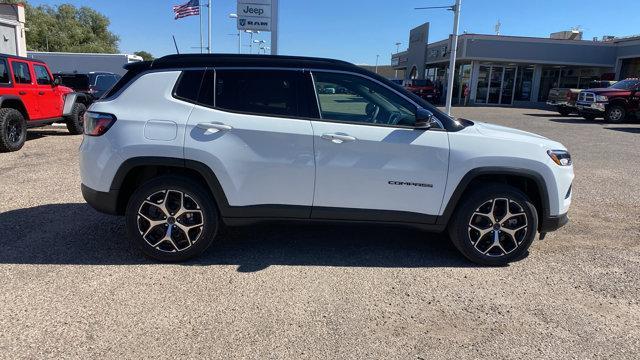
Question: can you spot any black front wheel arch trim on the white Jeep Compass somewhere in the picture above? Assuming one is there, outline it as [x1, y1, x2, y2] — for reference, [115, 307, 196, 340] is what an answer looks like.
[437, 167, 550, 231]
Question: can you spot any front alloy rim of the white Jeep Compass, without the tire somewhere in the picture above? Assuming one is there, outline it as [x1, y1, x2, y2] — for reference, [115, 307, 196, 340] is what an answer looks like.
[468, 198, 528, 257]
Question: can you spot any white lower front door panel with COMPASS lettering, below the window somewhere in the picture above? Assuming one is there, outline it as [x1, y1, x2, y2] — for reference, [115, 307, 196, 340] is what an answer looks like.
[312, 121, 449, 217]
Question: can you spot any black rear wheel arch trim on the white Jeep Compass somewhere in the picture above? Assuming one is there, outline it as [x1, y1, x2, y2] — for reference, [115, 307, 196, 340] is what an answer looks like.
[111, 157, 229, 216]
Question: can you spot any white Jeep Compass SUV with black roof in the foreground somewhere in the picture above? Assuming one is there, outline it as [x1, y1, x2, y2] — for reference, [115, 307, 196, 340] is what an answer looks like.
[80, 55, 574, 265]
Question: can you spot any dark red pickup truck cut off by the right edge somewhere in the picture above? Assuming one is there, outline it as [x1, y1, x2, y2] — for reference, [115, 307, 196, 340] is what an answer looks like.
[576, 79, 640, 123]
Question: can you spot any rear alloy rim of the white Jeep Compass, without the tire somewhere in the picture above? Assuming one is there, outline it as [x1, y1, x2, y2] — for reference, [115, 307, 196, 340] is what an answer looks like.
[137, 189, 205, 253]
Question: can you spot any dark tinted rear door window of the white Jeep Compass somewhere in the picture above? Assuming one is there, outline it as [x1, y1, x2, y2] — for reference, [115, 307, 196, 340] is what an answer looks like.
[210, 70, 299, 116]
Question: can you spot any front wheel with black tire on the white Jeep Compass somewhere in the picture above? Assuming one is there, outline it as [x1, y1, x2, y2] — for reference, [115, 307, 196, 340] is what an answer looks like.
[449, 184, 538, 266]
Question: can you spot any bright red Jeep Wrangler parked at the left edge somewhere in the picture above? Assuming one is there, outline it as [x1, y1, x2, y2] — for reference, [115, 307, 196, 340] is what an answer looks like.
[0, 55, 89, 152]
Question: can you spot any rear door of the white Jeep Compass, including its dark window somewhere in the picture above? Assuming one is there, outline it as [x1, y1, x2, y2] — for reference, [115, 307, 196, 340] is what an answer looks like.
[185, 70, 315, 212]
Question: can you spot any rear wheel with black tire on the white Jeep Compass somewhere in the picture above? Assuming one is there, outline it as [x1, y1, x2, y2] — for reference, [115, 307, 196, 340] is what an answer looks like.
[125, 176, 220, 262]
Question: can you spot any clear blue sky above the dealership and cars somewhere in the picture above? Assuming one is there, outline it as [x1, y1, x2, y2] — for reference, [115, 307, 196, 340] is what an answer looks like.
[29, 0, 640, 64]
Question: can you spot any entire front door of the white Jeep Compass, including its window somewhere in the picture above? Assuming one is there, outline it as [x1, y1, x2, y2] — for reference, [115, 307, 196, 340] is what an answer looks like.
[312, 71, 449, 217]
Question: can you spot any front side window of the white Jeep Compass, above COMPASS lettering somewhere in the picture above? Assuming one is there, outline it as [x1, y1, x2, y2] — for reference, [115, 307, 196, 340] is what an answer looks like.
[313, 72, 416, 126]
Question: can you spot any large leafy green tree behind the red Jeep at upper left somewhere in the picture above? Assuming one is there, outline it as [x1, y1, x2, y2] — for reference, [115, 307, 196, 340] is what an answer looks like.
[4, 0, 120, 54]
